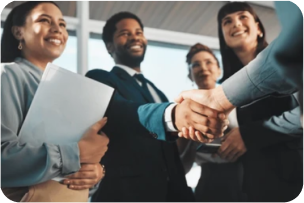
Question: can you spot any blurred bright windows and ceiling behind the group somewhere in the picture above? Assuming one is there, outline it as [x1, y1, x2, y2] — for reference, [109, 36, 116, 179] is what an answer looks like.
[1, 1, 280, 191]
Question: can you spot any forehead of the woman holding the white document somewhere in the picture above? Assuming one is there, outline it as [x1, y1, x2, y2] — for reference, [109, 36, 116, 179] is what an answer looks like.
[28, 3, 62, 18]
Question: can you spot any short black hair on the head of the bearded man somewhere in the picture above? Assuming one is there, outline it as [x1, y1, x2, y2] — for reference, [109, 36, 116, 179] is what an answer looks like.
[102, 11, 144, 45]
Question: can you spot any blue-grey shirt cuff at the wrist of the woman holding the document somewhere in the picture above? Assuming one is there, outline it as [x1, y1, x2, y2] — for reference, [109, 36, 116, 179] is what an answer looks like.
[59, 142, 81, 175]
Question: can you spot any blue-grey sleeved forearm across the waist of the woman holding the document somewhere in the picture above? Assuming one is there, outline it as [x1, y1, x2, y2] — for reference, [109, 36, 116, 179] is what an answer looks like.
[1, 132, 80, 187]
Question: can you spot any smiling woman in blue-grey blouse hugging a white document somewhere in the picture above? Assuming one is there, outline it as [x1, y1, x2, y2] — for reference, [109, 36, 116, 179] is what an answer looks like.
[1, 1, 109, 203]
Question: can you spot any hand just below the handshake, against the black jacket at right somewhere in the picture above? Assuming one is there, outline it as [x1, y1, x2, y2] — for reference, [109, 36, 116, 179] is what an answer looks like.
[218, 128, 247, 162]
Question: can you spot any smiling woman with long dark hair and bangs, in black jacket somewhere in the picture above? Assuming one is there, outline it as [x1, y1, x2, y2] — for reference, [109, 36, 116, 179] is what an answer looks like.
[217, 2, 304, 203]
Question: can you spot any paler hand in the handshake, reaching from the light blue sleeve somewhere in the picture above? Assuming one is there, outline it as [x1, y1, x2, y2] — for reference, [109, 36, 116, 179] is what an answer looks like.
[175, 86, 234, 114]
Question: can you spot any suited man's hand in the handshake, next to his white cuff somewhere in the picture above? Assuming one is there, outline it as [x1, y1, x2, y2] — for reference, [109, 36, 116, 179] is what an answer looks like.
[173, 99, 228, 142]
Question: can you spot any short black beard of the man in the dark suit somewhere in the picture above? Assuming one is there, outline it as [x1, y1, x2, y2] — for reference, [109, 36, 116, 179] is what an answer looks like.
[117, 47, 146, 67]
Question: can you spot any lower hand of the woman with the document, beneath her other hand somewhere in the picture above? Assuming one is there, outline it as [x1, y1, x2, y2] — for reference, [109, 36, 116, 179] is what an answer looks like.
[63, 163, 105, 190]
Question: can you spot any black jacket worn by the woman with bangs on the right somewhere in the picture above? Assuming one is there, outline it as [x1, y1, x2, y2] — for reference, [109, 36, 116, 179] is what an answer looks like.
[237, 95, 304, 203]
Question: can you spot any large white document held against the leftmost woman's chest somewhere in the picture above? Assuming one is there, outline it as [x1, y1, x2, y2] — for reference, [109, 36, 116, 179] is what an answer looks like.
[19, 63, 114, 180]
